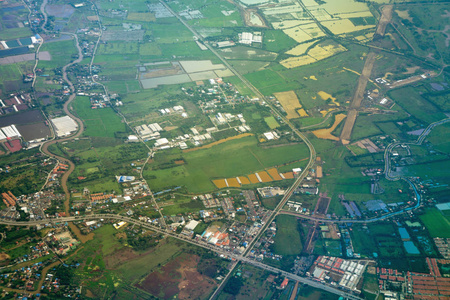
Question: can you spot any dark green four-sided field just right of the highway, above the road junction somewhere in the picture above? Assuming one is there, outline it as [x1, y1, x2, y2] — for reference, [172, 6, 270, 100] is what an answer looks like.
[274, 215, 302, 255]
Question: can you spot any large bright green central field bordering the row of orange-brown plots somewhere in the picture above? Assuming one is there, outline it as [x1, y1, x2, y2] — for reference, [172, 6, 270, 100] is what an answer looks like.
[144, 137, 308, 192]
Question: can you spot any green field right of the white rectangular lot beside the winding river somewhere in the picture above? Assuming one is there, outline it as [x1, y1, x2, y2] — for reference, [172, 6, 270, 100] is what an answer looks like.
[73, 97, 126, 137]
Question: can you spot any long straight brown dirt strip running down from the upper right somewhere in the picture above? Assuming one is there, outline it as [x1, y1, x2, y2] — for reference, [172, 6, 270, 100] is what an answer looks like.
[340, 5, 393, 144]
